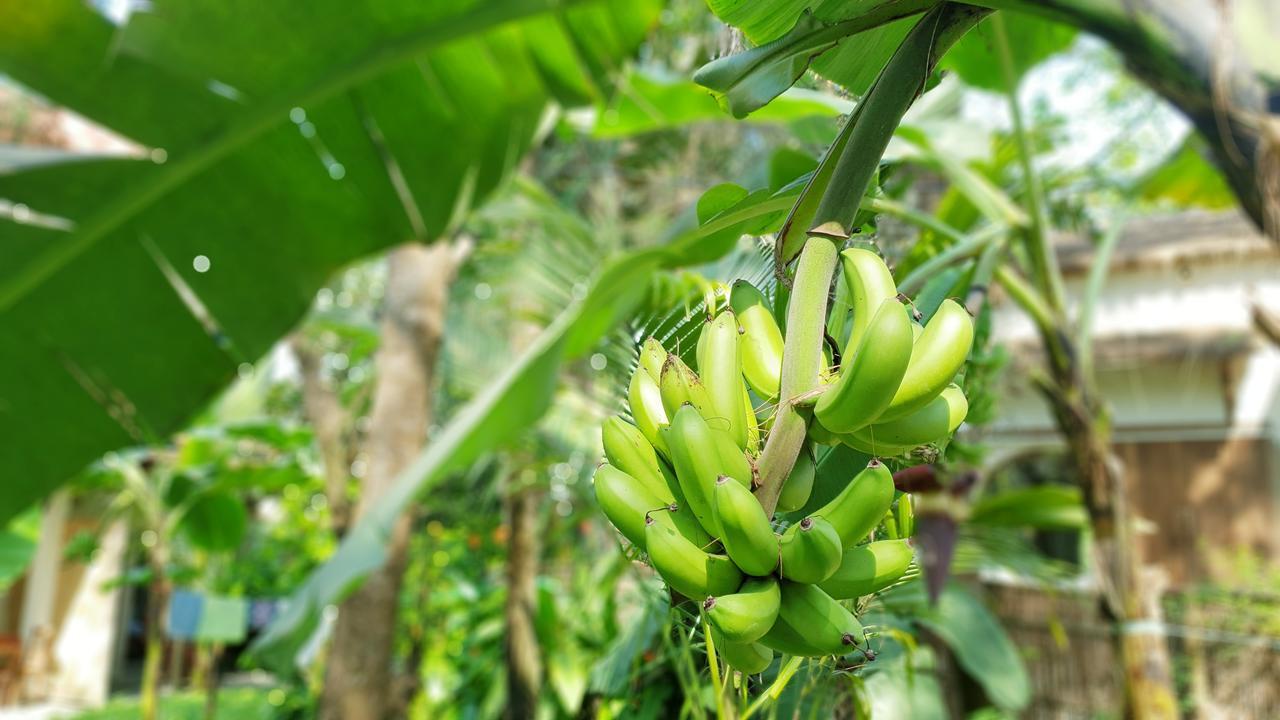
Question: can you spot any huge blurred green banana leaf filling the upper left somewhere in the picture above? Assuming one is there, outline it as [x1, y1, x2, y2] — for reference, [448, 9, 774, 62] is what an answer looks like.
[0, 0, 658, 521]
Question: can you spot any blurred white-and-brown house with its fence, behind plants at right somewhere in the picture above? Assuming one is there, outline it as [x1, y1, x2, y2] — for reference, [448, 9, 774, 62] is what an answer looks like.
[984, 213, 1280, 717]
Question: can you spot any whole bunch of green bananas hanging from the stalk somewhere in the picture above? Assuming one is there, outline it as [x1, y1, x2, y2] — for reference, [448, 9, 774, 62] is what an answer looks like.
[595, 249, 973, 674]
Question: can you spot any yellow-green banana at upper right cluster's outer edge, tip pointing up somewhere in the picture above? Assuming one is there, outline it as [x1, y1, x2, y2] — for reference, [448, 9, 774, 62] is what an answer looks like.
[878, 300, 973, 423]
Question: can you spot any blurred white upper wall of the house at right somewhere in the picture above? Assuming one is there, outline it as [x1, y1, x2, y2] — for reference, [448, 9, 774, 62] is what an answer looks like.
[991, 238, 1280, 445]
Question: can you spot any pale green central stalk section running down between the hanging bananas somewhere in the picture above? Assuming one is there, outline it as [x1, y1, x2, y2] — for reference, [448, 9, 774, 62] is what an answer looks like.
[755, 237, 838, 516]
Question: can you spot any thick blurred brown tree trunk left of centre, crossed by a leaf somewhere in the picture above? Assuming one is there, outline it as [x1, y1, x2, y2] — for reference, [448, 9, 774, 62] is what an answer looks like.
[320, 243, 457, 720]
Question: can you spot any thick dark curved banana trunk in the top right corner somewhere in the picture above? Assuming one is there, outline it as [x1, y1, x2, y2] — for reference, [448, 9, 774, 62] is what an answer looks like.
[979, 0, 1280, 241]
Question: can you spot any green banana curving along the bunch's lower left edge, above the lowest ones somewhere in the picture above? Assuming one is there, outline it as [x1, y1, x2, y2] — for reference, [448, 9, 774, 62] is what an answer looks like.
[644, 512, 742, 600]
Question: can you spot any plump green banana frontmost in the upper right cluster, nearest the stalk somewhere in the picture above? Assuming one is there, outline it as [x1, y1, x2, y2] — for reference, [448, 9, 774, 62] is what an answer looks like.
[814, 299, 911, 433]
